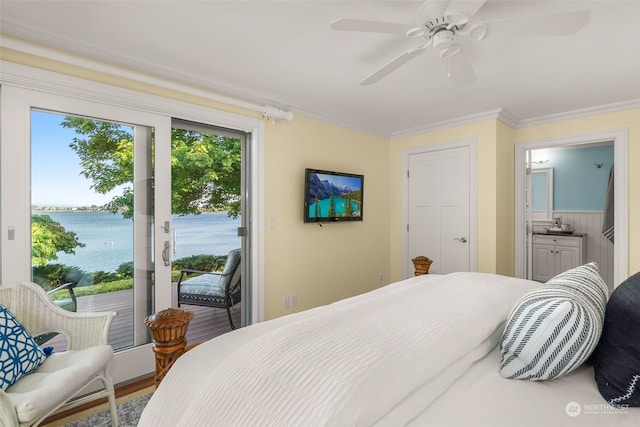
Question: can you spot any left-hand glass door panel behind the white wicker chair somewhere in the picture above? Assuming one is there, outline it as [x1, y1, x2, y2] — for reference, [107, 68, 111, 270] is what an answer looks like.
[31, 110, 153, 351]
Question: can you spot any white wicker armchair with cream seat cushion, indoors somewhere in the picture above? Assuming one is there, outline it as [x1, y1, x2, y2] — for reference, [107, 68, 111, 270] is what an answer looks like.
[0, 283, 118, 427]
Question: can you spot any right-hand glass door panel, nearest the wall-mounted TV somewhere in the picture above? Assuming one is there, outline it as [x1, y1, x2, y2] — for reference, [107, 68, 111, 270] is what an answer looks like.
[171, 119, 245, 342]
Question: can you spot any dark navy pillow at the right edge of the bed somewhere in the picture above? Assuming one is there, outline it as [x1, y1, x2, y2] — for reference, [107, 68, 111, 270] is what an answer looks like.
[591, 273, 640, 407]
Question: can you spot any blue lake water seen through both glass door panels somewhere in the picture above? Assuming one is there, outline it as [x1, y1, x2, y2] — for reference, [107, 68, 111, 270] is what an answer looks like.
[33, 211, 240, 272]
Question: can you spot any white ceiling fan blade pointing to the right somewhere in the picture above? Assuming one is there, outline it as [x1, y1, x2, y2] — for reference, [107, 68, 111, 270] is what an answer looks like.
[486, 10, 590, 37]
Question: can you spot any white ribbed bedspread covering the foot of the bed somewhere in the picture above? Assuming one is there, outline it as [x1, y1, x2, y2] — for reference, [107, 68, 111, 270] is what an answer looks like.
[139, 273, 535, 427]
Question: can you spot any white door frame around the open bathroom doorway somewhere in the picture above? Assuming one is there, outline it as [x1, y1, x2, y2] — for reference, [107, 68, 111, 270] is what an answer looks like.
[514, 128, 629, 288]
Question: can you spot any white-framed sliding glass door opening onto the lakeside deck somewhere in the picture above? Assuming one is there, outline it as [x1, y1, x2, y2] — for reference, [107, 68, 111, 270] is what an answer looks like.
[0, 79, 264, 383]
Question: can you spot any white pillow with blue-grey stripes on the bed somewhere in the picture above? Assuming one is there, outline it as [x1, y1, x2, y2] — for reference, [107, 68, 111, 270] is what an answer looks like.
[500, 263, 609, 381]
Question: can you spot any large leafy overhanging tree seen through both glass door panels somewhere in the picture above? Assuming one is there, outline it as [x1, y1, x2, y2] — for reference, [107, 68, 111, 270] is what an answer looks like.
[62, 117, 241, 218]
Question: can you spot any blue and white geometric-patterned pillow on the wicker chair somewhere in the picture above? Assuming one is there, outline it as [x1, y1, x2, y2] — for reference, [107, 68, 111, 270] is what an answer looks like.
[0, 304, 47, 390]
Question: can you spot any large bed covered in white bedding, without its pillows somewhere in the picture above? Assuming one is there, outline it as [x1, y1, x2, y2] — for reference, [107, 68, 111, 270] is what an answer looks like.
[139, 266, 640, 427]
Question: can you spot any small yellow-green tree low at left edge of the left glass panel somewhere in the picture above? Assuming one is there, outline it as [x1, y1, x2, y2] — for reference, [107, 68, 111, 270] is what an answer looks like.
[31, 215, 85, 266]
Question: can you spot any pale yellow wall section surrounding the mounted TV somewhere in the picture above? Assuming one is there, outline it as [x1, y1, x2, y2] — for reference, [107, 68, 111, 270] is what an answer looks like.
[265, 116, 389, 318]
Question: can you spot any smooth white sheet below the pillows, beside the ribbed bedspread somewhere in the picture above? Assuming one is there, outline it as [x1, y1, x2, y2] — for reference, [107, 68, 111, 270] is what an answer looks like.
[409, 347, 640, 427]
